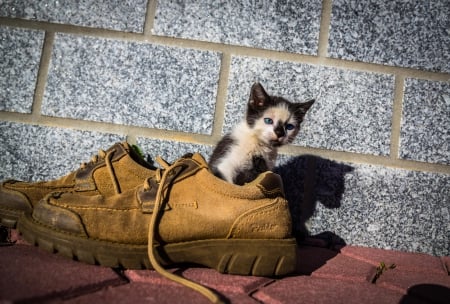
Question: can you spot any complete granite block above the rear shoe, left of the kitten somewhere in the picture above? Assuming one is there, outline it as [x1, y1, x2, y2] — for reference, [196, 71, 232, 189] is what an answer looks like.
[42, 34, 220, 134]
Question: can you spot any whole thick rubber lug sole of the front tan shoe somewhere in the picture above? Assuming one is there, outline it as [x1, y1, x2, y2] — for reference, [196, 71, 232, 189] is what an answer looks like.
[17, 214, 297, 277]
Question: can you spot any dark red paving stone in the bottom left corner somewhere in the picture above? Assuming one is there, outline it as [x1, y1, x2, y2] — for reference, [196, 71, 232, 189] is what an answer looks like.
[0, 245, 126, 303]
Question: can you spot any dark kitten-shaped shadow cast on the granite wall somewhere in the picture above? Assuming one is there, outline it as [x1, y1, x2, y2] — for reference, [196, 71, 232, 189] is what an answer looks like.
[274, 155, 353, 245]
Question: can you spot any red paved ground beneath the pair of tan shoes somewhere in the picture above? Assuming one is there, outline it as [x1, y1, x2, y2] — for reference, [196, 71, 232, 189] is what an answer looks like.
[0, 230, 450, 304]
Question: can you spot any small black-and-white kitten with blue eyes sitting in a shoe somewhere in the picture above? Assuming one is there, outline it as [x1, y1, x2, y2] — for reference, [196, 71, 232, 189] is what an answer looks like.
[209, 83, 314, 185]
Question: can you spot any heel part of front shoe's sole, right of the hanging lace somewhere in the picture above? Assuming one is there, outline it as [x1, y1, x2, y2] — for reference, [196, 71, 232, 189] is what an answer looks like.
[160, 239, 297, 276]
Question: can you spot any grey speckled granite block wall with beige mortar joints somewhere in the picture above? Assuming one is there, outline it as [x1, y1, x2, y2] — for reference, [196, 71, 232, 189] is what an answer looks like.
[0, 0, 450, 255]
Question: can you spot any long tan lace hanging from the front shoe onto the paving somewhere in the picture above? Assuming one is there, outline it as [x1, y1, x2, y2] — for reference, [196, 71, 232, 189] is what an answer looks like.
[144, 156, 223, 303]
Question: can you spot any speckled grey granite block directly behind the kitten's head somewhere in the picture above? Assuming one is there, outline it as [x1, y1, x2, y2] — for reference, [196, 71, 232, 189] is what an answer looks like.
[224, 57, 394, 155]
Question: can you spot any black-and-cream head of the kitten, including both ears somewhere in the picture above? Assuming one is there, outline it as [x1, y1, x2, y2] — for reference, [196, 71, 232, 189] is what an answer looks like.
[246, 83, 314, 147]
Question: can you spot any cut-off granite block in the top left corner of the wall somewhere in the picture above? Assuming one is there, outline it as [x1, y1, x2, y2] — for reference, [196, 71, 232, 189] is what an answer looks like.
[0, 0, 147, 32]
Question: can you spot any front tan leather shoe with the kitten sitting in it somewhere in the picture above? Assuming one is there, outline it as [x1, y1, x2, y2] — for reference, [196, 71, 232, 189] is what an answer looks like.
[18, 154, 296, 276]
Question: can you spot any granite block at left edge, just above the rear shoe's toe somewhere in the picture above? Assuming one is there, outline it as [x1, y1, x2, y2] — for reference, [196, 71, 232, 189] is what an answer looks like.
[0, 121, 125, 181]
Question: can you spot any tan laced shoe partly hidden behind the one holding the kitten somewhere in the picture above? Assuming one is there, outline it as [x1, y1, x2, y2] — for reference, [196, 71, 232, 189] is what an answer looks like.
[0, 142, 155, 228]
